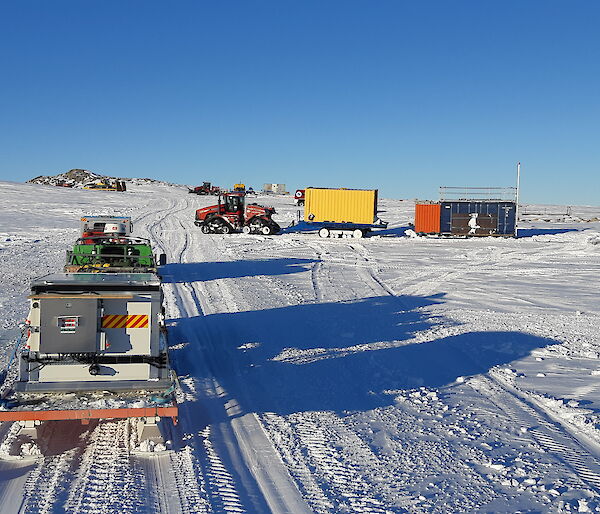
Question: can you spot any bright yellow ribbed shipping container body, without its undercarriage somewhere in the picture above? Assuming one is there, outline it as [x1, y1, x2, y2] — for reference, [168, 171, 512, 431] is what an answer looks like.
[304, 187, 377, 225]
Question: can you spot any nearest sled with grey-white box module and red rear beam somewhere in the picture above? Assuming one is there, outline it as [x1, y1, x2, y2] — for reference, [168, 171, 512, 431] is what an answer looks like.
[0, 273, 178, 448]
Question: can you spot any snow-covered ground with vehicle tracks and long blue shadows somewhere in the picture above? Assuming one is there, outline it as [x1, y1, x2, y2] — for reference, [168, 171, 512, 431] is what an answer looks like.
[0, 182, 600, 508]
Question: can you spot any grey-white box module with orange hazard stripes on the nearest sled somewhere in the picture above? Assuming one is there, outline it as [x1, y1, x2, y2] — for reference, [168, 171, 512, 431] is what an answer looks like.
[15, 273, 171, 392]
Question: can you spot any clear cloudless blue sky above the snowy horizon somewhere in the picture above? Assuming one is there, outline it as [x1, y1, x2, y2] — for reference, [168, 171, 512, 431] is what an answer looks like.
[0, 0, 600, 205]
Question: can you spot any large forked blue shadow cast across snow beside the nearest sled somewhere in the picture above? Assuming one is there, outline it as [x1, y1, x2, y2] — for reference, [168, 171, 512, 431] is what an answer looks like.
[165, 296, 555, 414]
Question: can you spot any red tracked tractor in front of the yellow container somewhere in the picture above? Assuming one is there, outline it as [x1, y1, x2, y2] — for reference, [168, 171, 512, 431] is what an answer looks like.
[194, 193, 281, 236]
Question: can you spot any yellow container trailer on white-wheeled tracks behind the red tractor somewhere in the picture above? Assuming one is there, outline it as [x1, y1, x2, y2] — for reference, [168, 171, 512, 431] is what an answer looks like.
[304, 187, 387, 238]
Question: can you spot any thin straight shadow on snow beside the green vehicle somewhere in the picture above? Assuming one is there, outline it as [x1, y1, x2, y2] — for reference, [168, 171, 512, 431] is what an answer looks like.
[160, 258, 317, 283]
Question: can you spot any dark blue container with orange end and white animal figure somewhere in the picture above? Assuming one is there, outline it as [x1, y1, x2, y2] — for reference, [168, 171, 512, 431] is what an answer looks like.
[414, 187, 517, 237]
